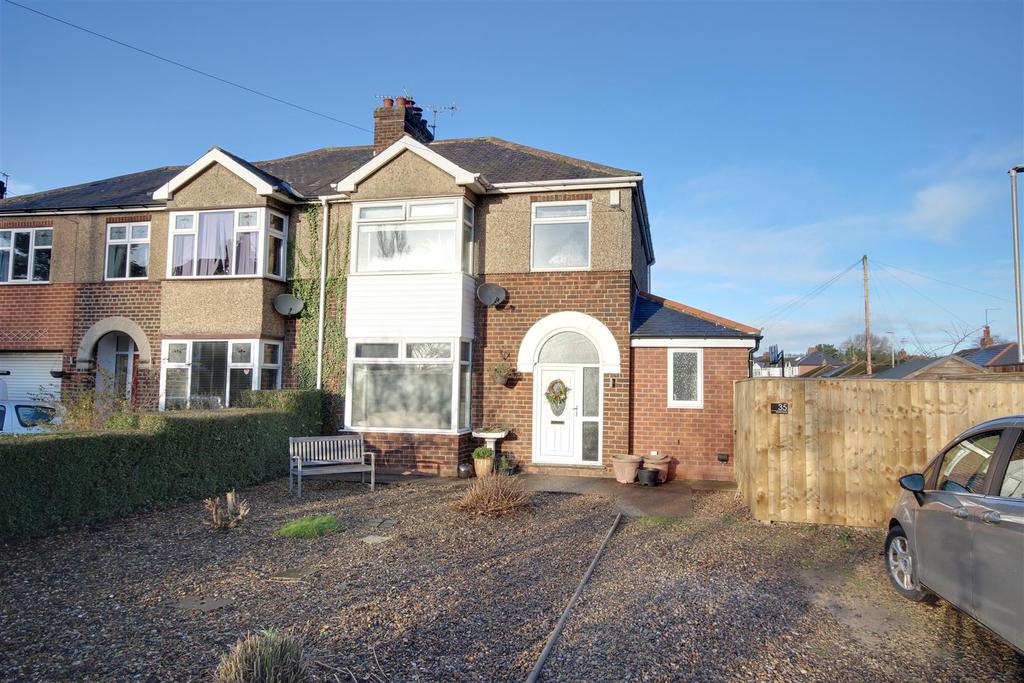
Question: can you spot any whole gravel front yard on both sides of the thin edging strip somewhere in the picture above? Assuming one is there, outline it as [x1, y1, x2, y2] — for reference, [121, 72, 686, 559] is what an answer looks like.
[0, 480, 1024, 682]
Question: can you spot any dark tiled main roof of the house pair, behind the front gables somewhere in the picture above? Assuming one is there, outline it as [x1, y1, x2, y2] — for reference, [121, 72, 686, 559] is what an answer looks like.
[0, 137, 642, 213]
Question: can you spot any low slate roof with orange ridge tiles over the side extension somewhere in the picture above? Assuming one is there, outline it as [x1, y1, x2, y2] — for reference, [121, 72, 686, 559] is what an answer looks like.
[630, 292, 761, 339]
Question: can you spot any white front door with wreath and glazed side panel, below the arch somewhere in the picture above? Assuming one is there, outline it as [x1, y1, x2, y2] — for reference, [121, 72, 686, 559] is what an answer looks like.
[534, 365, 602, 465]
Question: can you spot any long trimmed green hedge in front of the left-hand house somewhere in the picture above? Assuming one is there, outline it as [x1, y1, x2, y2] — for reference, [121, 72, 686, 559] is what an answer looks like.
[0, 391, 323, 539]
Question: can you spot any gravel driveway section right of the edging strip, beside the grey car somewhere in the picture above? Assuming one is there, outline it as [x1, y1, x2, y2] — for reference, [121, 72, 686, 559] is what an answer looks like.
[543, 493, 1024, 683]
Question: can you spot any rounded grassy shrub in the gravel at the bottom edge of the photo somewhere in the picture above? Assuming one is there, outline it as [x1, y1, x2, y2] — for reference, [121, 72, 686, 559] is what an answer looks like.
[213, 629, 306, 683]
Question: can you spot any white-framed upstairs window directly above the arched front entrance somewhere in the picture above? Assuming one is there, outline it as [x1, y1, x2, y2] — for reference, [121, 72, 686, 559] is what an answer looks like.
[530, 200, 591, 270]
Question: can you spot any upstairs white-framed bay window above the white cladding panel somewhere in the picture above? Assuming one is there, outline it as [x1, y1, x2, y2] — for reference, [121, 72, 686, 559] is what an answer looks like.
[351, 198, 476, 273]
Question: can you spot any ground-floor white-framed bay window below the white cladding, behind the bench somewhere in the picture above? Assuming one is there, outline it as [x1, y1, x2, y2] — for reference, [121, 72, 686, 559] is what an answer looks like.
[345, 339, 472, 433]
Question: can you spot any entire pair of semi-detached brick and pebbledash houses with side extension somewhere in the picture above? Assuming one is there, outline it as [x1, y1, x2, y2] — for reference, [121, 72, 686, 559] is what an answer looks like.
[0, 98, 760, 479]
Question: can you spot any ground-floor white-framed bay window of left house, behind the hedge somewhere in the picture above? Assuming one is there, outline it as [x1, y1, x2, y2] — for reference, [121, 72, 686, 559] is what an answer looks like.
[160, 339, 284, 411]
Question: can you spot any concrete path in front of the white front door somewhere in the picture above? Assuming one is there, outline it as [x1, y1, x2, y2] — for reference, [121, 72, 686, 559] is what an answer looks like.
[519, 474, 693, 517]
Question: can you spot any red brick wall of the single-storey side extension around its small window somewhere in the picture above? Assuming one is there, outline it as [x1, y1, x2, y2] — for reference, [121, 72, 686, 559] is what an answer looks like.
[630, 348, 748, 481]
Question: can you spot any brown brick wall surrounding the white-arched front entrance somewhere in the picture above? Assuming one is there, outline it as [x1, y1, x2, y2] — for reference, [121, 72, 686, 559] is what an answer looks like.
[473, 270, 632, 474]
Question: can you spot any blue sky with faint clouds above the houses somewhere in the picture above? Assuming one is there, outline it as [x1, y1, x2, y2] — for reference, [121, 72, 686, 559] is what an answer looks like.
[0, 0, 1024, 352]
